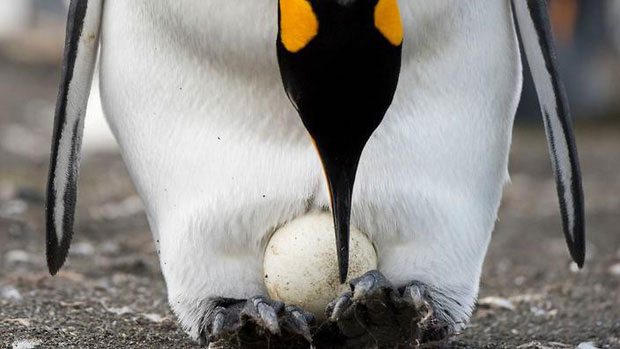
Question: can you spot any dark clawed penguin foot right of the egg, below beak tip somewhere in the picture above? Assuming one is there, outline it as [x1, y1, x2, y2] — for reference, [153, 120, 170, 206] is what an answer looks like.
[315, 270, 455, 348]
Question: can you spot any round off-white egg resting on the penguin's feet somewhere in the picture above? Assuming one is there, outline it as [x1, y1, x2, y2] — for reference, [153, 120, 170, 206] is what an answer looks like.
[263, 213, 377, 321]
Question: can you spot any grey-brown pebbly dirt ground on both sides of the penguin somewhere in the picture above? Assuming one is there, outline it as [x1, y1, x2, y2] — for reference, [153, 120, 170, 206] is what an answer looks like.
[0, 55, 620, 348]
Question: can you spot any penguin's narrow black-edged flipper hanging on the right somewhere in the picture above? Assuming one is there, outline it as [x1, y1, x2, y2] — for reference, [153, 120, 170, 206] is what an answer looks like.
[512, 0, 585, 267]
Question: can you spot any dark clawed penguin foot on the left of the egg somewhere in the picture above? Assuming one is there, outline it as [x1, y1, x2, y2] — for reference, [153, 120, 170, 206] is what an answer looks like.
[199, 296, 315, 349]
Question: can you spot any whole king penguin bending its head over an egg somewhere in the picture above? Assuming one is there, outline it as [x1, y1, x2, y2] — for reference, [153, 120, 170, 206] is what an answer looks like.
[46, 0, 585, 347]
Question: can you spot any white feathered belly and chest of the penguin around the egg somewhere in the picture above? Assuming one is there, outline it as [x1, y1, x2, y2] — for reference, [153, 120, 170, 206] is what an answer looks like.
[100, 0, 521, 338]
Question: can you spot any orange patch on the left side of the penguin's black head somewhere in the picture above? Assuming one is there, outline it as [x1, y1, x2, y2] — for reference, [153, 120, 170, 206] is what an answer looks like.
[280, 0, 319, 53]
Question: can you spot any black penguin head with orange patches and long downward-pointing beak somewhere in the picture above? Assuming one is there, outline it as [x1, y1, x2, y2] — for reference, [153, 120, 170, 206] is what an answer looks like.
[277, 0, 403, 282]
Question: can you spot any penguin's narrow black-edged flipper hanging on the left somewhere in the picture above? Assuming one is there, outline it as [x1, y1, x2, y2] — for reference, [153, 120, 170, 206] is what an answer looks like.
[45, 0, 103, 275]
